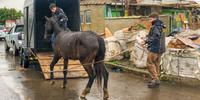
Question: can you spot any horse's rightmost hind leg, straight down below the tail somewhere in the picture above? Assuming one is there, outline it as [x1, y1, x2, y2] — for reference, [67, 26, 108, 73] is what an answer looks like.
[101, 62, 109, 99]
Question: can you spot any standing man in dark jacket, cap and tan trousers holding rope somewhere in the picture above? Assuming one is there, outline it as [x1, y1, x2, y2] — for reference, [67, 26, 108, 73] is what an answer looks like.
[146, 13, 165, 88]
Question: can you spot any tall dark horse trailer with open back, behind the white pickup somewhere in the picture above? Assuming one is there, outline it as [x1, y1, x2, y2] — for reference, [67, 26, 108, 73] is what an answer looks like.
[21, 0, 84, 79]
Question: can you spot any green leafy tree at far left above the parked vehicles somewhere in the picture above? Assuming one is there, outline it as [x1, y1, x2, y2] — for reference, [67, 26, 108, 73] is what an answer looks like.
[0, 8, 22, 23]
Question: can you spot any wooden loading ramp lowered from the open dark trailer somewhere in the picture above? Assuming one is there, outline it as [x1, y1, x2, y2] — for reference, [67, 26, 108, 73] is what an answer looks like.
[37, 52, 88, 79]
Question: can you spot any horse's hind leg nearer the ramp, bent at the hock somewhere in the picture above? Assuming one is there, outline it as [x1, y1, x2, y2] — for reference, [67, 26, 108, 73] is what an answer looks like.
[81, 61, 96, 98]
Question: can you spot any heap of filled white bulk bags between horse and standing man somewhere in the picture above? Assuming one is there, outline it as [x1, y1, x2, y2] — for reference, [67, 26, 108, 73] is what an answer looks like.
[102, 24, 148, 68]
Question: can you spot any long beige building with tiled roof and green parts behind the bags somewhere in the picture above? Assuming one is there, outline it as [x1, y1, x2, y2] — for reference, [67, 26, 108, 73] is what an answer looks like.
[80, 0, 200, 34]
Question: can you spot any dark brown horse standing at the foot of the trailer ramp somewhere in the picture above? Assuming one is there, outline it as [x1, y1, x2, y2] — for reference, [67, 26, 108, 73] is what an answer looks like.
[44, 17, 109, 99]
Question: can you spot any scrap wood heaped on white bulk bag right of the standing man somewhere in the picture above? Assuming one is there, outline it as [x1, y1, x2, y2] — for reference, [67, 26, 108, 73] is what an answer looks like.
[161, 30, 200, 79]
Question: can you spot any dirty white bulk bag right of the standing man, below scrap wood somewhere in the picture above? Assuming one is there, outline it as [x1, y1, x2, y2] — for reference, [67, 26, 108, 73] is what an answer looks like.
[161, 49, 200, 80]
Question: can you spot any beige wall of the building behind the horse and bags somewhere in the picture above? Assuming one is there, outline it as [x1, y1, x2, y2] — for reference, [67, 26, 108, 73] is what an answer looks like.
[80, 5, 170, 34]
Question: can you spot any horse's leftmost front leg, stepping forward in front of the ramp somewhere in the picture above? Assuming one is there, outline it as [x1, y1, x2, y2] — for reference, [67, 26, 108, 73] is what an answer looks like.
[50, 55, 60, 85]
